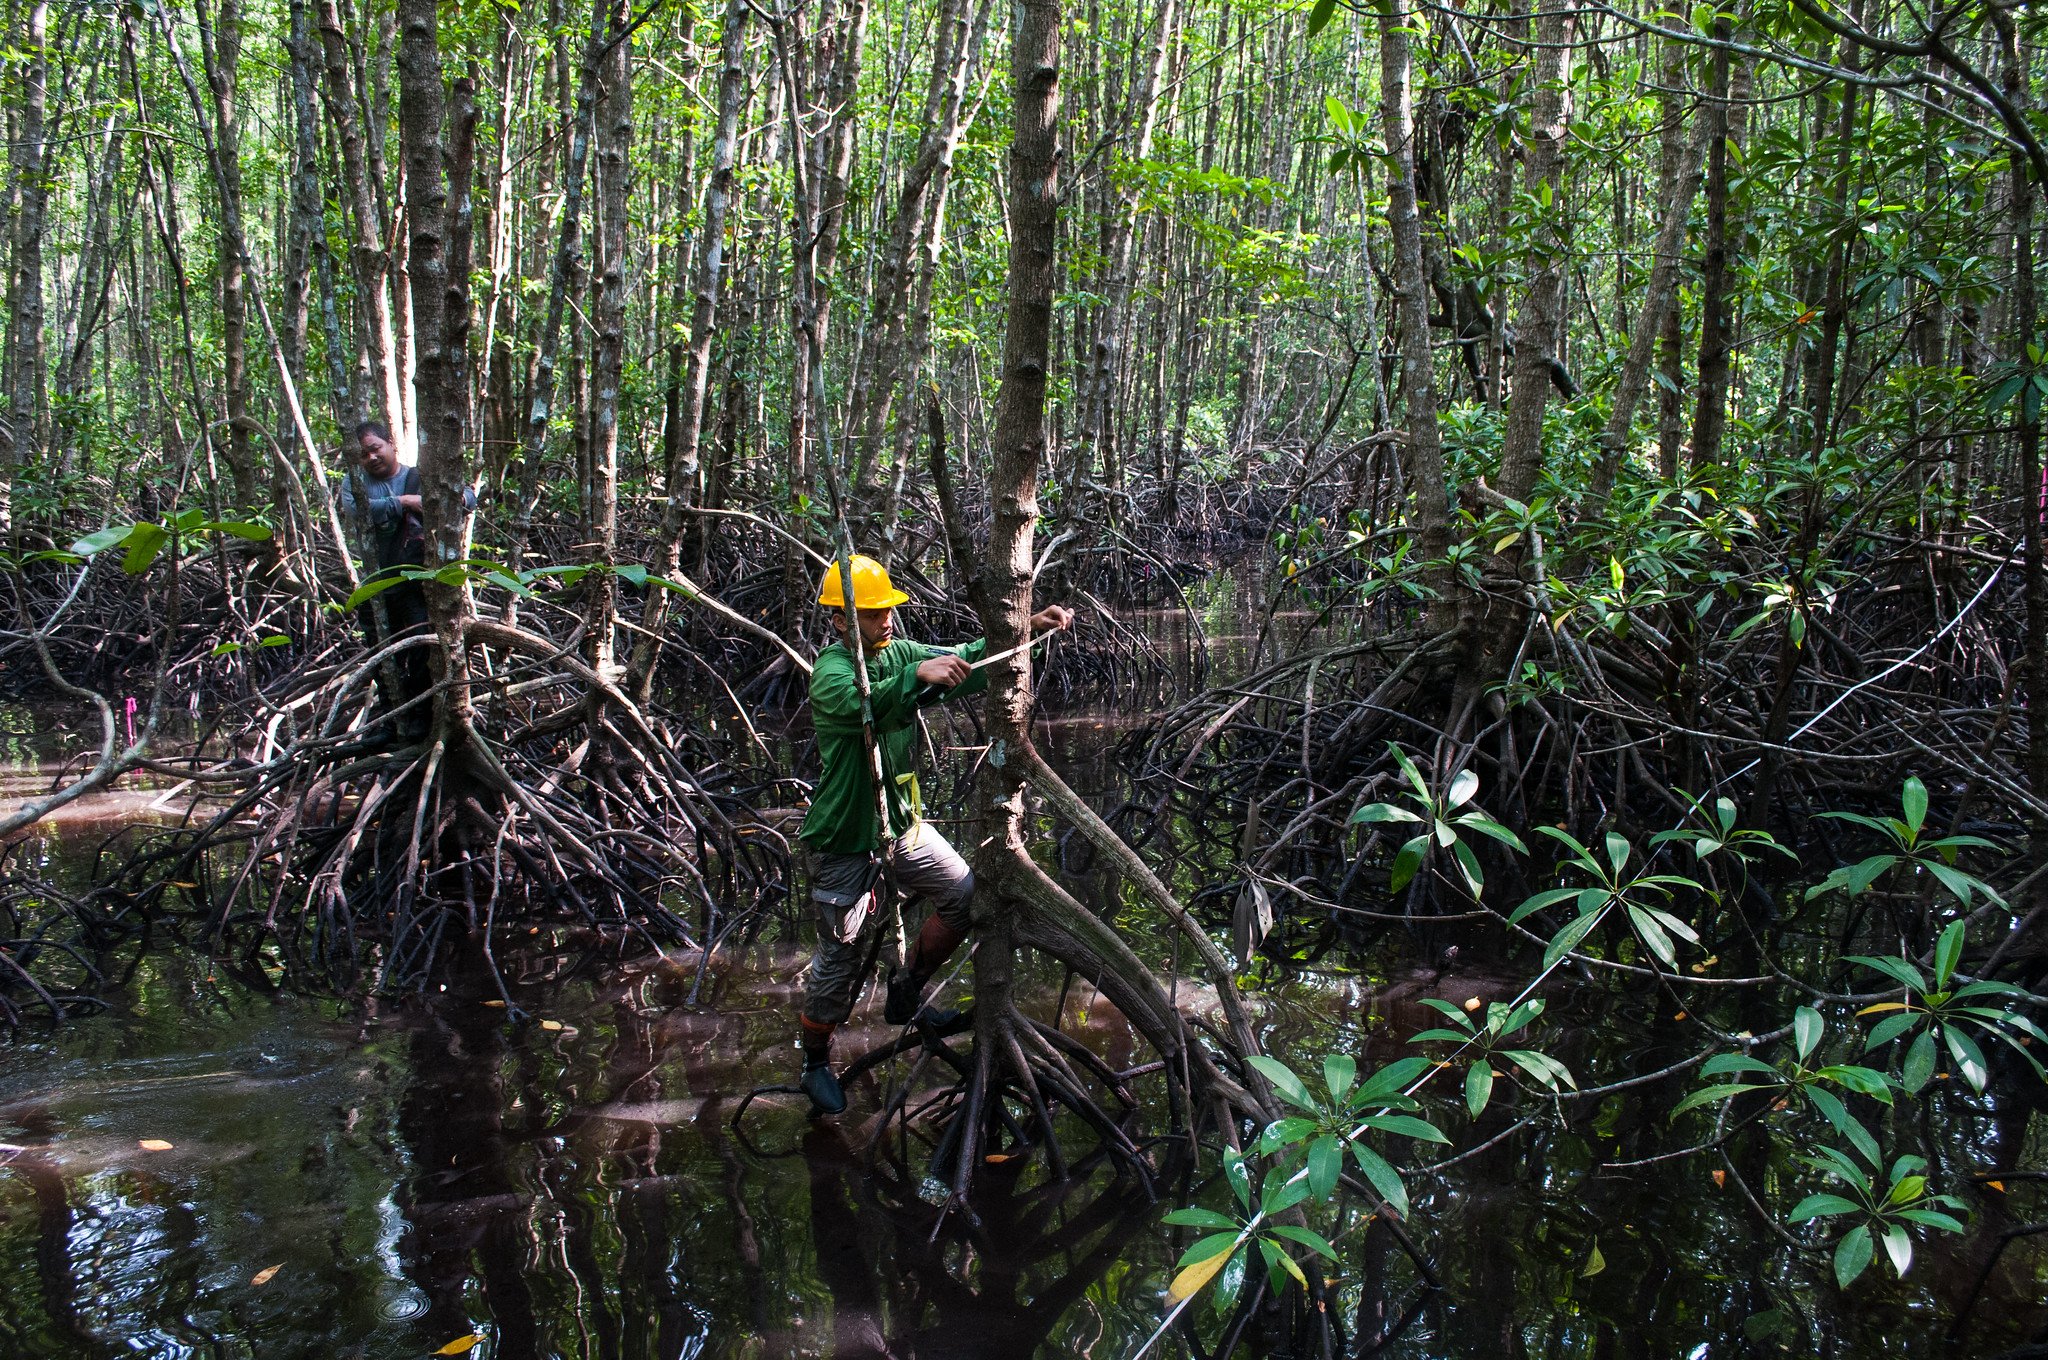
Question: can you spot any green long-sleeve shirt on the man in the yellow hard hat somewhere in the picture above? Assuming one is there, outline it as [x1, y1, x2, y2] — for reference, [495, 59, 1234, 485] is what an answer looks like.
[797, 637, 989, 854]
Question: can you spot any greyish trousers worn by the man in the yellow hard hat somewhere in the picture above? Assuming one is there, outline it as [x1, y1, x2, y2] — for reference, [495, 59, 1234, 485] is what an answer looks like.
[801, 821, 975, 1030]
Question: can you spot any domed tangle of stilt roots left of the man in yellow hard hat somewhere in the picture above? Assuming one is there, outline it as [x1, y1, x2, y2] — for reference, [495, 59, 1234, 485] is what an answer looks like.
[103, 621, 788, 987]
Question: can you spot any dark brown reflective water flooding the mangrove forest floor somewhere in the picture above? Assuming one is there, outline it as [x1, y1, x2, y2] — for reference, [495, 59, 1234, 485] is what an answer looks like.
[0, 585, 2048, 1360]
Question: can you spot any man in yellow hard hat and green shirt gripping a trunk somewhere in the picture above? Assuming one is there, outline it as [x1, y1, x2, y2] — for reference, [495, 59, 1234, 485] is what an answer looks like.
[797, 557, 1073, 1114]
